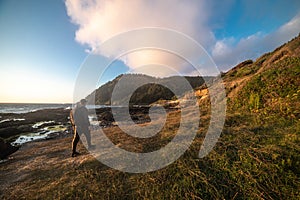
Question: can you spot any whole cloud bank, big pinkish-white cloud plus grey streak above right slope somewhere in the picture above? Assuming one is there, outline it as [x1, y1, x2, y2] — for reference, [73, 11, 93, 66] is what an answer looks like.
[65, 0, 300, 74]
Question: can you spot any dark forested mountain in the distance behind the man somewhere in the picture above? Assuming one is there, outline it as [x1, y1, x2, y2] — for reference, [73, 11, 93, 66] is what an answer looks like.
[86, 74, 212, 105]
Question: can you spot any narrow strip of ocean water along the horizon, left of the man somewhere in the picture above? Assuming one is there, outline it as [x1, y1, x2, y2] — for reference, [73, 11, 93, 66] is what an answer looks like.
[0, 103, 72, 113]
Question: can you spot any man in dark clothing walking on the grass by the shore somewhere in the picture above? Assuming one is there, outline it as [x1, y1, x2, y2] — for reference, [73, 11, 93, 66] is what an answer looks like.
[70, 99, 93, 157]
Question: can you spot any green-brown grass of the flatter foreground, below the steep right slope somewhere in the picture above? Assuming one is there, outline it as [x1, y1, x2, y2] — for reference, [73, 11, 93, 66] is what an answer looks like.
[4, 105, 300, 199]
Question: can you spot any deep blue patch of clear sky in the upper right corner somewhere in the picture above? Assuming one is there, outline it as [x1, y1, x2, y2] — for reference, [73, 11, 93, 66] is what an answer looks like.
[212, 0, 300, 40]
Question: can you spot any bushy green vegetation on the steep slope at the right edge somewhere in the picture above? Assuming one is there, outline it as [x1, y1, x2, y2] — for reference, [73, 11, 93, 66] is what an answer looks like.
[230, 58, 300, 115]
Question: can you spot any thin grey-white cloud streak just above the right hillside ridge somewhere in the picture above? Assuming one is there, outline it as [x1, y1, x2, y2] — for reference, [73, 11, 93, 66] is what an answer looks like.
[212, 14, 300, 71]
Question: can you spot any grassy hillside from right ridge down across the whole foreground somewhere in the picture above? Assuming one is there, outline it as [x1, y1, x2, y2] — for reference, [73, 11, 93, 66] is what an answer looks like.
[0, 37, 300, 199]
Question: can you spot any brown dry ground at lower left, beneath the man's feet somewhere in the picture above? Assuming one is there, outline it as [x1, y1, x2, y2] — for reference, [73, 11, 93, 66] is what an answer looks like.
[0, 134, 93, 199]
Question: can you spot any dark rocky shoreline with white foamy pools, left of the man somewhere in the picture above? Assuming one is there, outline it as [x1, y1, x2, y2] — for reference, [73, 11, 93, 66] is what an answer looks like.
[0, 108, 70, 159]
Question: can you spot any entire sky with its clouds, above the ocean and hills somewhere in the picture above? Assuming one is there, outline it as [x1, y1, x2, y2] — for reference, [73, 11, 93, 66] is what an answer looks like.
[0, 0, 300, 103]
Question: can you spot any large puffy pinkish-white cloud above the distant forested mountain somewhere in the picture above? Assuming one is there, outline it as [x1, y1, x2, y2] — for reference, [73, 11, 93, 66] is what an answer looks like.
[66, 0, 214, 76]
